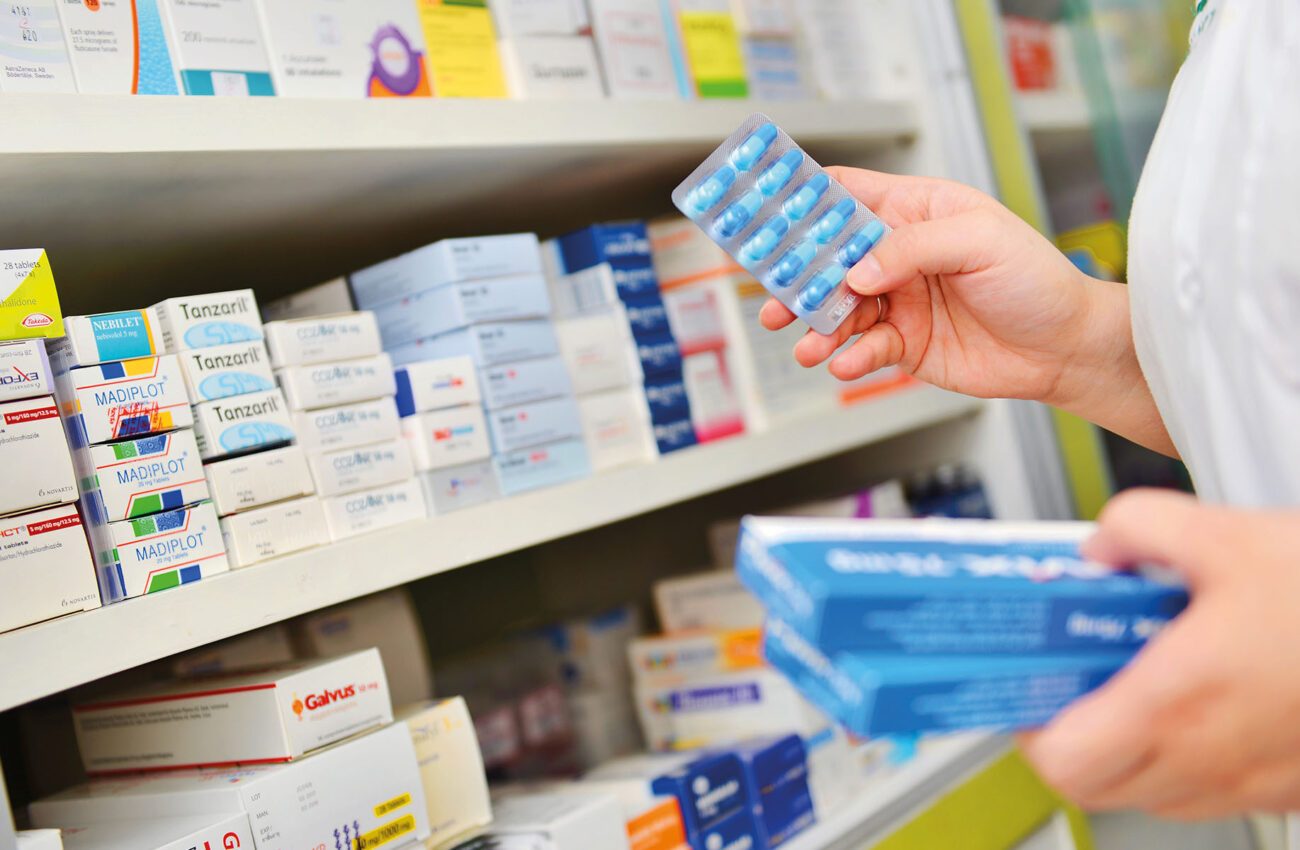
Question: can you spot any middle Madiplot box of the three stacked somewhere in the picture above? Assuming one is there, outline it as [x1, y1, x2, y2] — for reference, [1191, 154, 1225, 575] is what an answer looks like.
[77, 430, 209, 525]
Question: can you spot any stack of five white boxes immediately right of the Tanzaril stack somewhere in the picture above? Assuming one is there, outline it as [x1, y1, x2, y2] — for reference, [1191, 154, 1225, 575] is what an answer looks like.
[267, 311, 426, 542]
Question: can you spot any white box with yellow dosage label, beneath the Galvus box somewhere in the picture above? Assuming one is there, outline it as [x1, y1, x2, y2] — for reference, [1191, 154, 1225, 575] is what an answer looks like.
[29, 724, 429, 850]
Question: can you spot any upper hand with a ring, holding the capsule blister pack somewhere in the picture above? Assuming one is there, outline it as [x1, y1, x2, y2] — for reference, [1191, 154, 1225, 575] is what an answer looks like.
[762, 168, 1096, 400]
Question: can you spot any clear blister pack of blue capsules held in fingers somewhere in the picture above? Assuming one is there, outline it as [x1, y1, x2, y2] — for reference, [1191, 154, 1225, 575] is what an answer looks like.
[672, 113, 889, 334]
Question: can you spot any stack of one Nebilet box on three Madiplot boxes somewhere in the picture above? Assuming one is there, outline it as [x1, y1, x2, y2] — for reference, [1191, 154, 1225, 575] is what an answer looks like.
[51, 308, 229, 603]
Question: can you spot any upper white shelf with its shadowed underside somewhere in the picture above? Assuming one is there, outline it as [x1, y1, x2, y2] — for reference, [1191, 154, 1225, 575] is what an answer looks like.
[0, 94, 920, 312]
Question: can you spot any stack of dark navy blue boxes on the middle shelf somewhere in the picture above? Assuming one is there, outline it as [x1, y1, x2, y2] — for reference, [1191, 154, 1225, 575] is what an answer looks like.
[553, 221, 697, 454]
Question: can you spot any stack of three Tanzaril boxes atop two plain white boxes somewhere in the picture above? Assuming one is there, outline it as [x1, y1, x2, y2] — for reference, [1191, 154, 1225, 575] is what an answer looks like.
[153, 290, 325, 567]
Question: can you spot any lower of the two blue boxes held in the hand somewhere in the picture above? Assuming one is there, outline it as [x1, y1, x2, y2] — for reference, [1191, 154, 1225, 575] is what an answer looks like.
[763, 619, 1132, 737]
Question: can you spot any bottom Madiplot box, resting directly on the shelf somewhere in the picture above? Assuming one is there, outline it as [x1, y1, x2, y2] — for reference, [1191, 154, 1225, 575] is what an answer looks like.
[90, 502, 230, 602]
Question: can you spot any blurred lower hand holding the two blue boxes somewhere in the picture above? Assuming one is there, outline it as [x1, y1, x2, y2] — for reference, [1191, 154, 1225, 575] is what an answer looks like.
[1022, 490, 1300, 819]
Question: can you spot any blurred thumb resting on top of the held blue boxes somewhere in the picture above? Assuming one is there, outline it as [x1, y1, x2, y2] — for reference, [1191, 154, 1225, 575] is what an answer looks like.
[1080, 489, 1222, 586]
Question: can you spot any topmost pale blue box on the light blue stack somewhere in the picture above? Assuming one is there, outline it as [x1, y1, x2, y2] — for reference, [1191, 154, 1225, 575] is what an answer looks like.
[348, 233, 542, 309]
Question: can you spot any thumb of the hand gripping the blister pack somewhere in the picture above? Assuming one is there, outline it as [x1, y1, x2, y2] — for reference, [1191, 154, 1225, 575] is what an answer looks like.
[846, 211, 998, 295]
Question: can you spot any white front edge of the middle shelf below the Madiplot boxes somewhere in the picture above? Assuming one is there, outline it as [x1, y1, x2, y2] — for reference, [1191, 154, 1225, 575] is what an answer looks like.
[0, 385, 983, 711]
